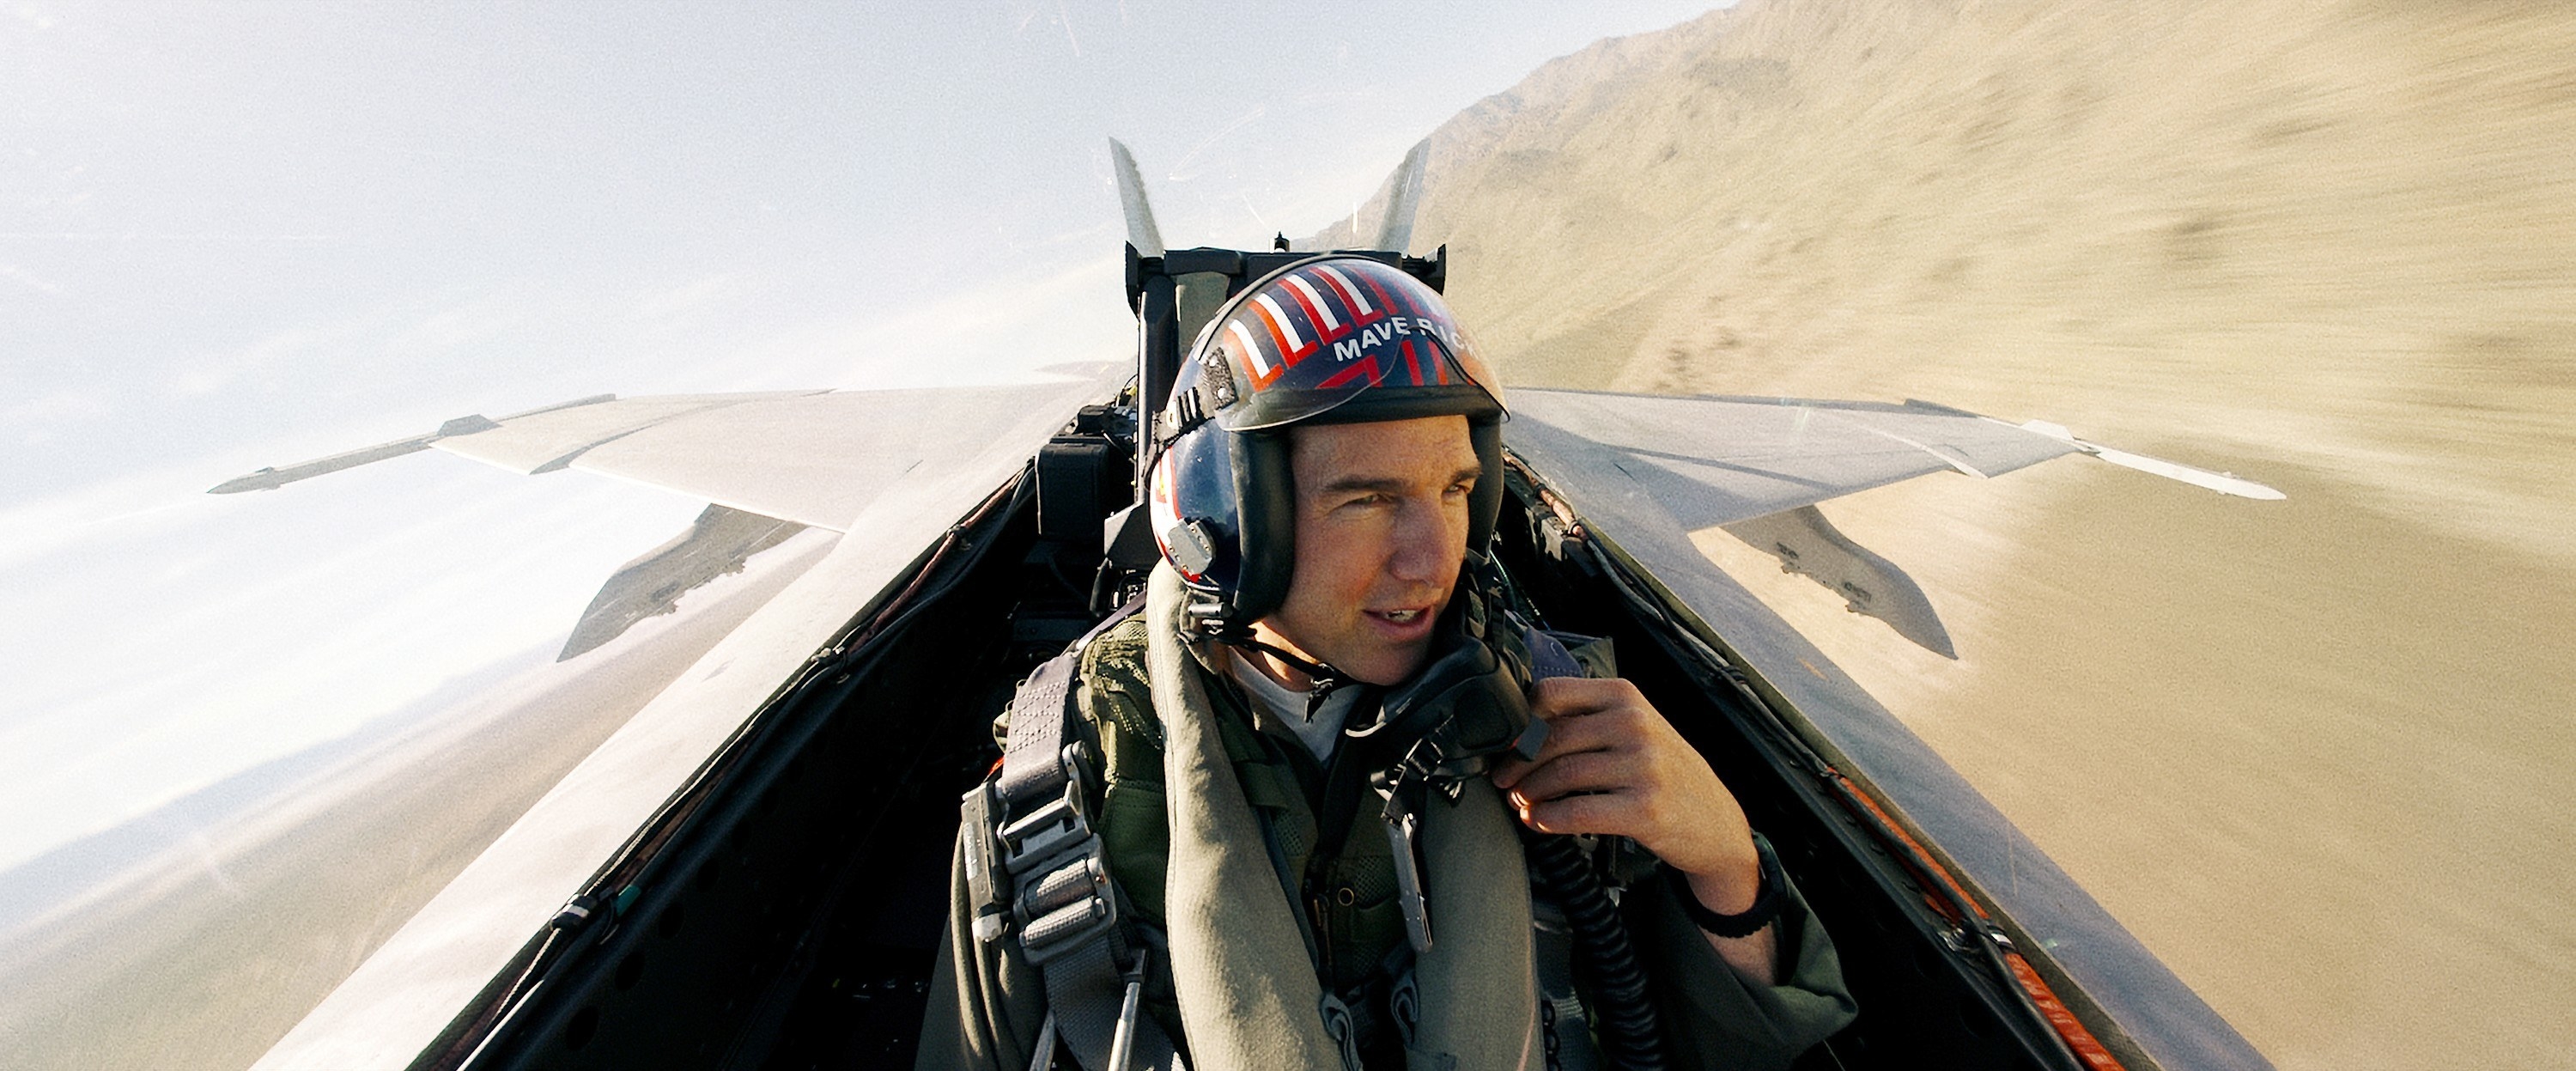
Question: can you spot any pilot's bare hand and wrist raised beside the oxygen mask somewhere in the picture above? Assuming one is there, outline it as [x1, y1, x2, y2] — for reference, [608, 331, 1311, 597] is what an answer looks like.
[1494, 677, 1775, 981]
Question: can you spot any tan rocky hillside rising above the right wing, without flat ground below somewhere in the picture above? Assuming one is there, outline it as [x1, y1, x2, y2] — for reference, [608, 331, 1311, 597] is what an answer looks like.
[1329, 0, 2576, 561]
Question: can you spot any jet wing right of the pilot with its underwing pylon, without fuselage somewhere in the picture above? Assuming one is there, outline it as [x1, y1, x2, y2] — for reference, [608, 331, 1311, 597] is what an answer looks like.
[1504, 389, 2282, 659]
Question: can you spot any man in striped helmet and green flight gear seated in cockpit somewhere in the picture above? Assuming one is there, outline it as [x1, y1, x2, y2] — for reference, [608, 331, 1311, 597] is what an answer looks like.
[917, 255, 1855, 1071]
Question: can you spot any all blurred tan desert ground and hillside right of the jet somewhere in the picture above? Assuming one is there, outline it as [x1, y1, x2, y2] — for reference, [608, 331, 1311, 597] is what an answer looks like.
[1327, 0, 2576, 1068]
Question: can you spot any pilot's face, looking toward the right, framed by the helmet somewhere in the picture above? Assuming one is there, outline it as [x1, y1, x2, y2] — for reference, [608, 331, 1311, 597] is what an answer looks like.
[1257, 417, 1481, 685]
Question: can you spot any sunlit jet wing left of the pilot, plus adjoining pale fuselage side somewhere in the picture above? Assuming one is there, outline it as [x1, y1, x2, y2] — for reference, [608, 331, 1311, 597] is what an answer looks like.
[242, 374, 1126, 1068]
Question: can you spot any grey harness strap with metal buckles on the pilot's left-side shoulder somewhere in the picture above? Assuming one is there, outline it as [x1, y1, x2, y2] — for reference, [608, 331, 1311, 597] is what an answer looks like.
[961, 599, 1185, 1071]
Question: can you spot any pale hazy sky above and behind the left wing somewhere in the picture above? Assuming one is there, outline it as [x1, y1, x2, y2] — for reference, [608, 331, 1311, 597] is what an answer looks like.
[0, 0, 1741, 896]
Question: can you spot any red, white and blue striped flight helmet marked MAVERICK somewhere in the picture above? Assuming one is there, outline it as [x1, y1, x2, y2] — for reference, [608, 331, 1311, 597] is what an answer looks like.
[1149, 255, 1507, 633]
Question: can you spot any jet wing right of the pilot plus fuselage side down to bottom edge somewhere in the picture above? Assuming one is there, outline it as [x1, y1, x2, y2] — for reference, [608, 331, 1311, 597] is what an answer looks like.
[1504, 389, 2282, 1068]
